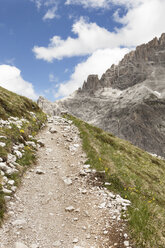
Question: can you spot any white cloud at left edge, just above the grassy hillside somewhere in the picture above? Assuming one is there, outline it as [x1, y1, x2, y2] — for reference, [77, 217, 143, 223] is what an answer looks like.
[0, 65, 38, 100]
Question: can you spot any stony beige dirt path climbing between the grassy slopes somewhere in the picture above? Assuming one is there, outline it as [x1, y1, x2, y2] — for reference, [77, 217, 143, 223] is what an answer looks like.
[0, 118, 130, 248]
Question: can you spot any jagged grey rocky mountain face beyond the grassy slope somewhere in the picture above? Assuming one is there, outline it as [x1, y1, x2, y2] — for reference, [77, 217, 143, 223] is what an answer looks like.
[39, 34, 165, 157]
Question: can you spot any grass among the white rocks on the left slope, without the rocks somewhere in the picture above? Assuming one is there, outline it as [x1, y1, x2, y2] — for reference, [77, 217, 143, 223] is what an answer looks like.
[0, 87, 46, 223]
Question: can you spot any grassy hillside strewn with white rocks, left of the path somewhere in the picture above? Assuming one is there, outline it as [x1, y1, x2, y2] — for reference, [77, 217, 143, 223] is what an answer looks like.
[0, 87, 46, 223]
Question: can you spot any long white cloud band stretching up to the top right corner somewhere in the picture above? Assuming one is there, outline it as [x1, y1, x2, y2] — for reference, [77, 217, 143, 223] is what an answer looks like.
[33, 0, 165, 62]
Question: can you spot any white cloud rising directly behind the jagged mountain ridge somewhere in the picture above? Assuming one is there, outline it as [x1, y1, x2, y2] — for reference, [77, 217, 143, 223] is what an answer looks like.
[55, 48, 129, 98]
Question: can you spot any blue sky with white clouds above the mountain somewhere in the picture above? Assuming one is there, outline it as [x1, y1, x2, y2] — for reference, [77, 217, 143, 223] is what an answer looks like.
[0, 0, 165, 101]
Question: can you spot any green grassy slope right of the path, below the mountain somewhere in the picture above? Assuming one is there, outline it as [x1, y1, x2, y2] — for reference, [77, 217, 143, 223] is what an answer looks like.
[66, 115, 165, 248]
